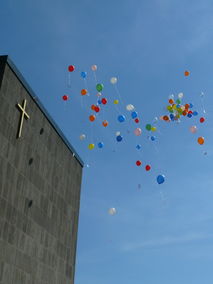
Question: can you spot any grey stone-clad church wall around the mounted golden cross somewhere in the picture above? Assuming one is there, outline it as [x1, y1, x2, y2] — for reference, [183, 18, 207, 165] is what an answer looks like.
[0, 56, 83, 284]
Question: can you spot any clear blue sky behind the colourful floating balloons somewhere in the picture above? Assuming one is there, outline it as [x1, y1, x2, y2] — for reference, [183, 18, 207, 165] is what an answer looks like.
[0, 0, 213, 284]
